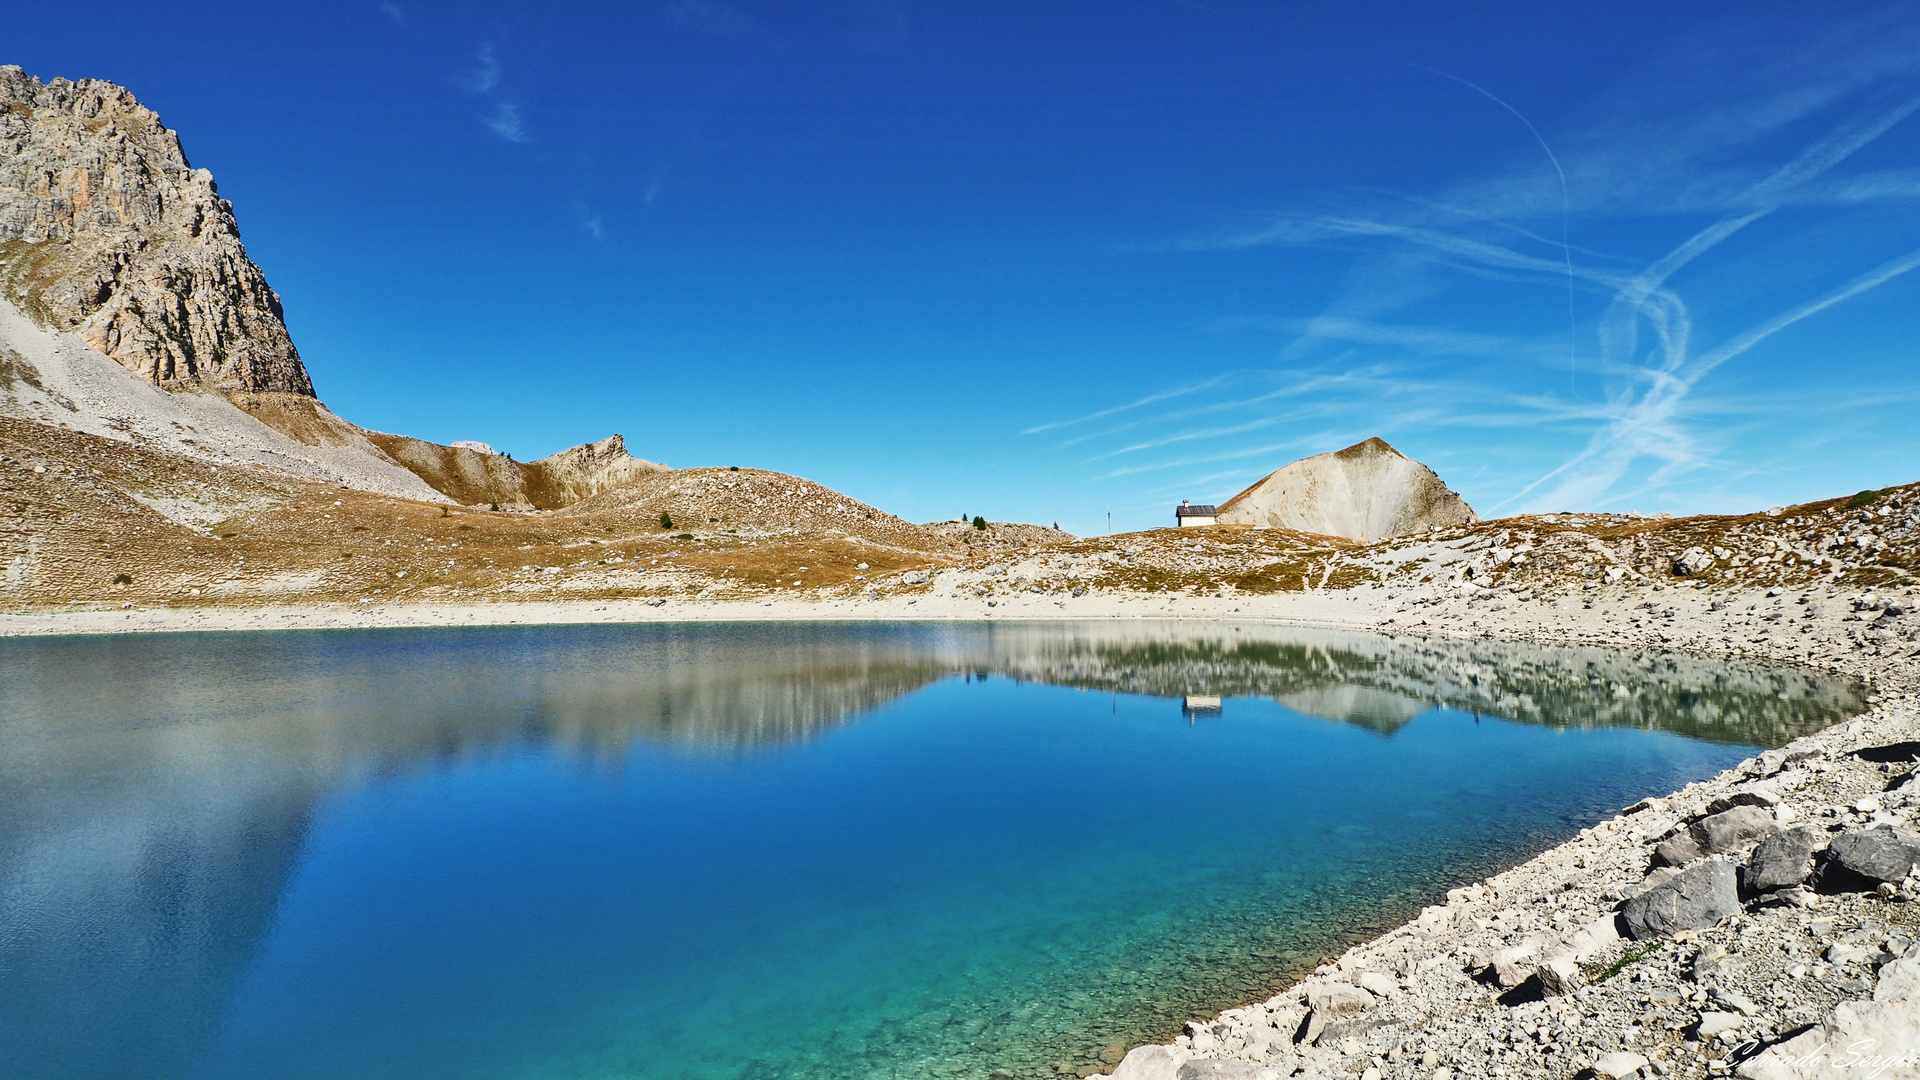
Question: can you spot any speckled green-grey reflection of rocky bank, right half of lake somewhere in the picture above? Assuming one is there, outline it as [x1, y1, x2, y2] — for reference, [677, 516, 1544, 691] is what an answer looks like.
[973, 623, 1862, 746]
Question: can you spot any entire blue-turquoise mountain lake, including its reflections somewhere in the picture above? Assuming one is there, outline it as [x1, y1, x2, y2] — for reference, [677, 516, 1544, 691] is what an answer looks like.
[0, 623, 1860, 1080]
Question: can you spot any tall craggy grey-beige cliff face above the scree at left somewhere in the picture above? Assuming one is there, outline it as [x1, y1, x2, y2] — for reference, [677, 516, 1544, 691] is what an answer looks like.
[0, 65, 313, 396]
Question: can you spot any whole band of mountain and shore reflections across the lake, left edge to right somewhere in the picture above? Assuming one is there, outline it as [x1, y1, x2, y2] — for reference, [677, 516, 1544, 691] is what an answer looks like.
[0, 623, 1860, 1076]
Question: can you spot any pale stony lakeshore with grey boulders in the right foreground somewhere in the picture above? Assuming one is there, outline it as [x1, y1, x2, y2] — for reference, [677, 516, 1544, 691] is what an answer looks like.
[1114, 596, 1920, 1080]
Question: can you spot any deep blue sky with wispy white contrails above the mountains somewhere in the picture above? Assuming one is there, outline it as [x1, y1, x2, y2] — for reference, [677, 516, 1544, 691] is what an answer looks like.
[11, 0, 1920, 532]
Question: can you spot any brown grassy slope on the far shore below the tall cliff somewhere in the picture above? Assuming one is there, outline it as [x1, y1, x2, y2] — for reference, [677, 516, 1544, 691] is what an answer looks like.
[0, 421, 966, 607]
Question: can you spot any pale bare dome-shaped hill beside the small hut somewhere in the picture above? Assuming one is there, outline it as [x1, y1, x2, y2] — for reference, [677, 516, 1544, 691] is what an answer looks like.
[1219, 438, 1476, 542]
